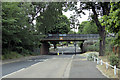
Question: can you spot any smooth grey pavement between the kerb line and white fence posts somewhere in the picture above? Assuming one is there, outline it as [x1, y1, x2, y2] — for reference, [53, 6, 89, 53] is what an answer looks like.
[69, 55, 106, 78]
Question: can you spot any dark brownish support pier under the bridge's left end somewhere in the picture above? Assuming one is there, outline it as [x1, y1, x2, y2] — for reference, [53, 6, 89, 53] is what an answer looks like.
[40, 42, 50, 55]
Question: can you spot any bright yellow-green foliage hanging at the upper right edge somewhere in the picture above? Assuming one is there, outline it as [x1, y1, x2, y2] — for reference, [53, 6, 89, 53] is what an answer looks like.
[102, 1, 120, 58]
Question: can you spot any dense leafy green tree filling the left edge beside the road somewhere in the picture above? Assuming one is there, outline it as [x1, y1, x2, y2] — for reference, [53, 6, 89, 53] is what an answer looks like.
[2, 2, 39, 54]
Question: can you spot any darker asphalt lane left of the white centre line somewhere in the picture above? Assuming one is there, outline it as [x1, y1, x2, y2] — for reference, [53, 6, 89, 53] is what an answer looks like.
[2, 56, 54, 76]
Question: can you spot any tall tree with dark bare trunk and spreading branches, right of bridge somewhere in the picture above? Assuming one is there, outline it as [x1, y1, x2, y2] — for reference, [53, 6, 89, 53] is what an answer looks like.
[65, 2, 110, 56]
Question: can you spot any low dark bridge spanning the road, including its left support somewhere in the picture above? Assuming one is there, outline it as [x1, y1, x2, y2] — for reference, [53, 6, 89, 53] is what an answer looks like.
[40, 34, 99, 54]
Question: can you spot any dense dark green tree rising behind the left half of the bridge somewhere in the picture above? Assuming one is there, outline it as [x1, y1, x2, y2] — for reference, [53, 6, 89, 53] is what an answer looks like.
[36, 2, 67, 34]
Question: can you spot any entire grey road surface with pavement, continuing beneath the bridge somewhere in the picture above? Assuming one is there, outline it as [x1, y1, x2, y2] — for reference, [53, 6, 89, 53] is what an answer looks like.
[2, 47, 106, 78]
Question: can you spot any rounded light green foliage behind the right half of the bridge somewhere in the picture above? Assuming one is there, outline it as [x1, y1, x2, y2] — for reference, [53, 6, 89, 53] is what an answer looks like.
[78, 21, 98, 34]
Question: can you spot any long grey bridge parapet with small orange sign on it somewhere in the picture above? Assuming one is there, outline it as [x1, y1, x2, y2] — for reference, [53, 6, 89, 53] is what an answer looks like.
[42, 34, 99, 41]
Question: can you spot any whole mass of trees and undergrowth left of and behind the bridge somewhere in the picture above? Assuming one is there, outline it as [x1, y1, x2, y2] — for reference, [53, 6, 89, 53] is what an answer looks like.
[2, 2, 70, 59]
